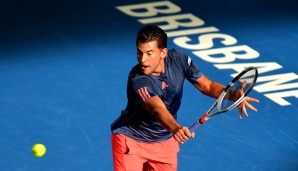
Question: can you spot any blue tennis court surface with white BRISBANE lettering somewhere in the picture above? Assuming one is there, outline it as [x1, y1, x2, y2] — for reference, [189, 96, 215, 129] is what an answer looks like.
[0, 0, 298, 171]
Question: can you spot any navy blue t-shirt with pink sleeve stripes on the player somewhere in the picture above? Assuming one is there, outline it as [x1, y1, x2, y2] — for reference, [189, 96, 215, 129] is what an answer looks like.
[111, 49, 202, 142]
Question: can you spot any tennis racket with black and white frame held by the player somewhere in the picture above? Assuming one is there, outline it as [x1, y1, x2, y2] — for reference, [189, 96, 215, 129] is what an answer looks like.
[189, 67, 258, 133]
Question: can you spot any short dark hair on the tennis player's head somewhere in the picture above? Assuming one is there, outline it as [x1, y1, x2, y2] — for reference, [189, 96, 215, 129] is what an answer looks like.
[136, 25, 168, 48]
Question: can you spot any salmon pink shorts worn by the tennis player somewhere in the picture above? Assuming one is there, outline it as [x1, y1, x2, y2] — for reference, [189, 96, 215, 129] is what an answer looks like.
[112, 134, 180, 171]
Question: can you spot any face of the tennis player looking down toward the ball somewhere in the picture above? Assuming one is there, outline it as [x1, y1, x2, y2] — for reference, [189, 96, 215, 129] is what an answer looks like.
[137, 41, 168, 76]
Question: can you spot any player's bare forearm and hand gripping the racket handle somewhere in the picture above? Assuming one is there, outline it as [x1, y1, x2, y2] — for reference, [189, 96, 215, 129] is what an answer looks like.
[144, 96, 194, 143]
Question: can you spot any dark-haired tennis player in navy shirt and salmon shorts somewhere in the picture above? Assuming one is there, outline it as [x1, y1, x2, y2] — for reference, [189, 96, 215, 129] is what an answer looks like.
[111, 25, 258, 171]
